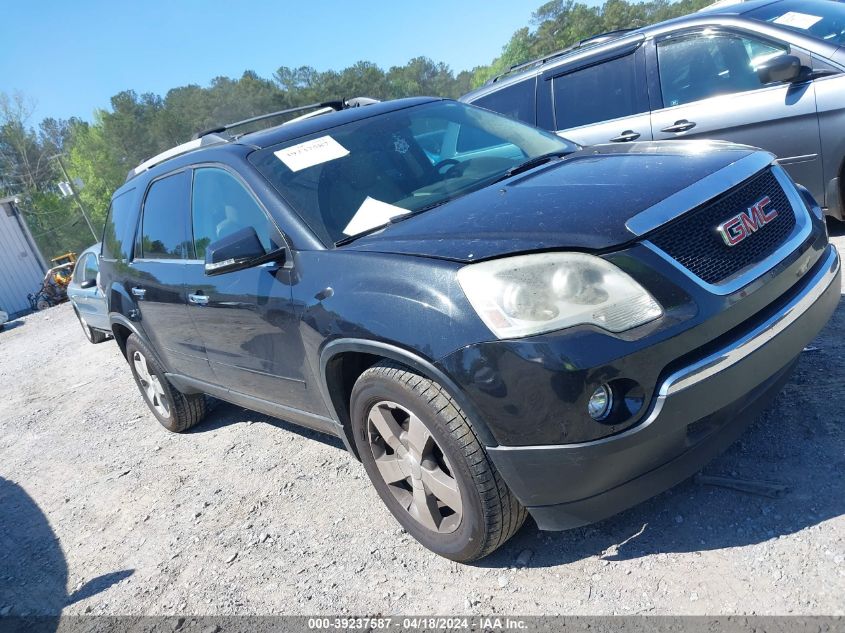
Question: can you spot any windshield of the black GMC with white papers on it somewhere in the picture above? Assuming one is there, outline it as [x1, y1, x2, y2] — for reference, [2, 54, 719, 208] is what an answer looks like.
[250, 101, 578, 244]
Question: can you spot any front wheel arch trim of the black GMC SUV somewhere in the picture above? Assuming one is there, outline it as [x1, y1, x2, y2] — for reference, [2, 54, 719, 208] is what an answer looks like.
[319, 338, 497, 459]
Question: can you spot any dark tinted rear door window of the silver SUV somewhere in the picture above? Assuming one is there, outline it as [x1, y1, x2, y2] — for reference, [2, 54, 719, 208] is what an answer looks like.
[552, 54, 648, 130]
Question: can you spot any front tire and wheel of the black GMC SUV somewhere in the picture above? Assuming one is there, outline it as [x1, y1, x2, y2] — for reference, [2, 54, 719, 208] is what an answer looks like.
[350, 361, 527, 562]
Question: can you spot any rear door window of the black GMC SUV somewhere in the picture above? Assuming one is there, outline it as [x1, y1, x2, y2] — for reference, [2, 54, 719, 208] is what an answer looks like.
[138, 171, 191, 259]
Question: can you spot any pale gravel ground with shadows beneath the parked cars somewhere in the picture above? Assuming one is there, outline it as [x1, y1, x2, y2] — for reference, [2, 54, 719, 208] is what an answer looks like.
[0, 226, 845, 615]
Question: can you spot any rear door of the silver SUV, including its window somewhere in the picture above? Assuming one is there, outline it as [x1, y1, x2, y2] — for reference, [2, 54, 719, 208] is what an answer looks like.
[544, 48, 651, 145]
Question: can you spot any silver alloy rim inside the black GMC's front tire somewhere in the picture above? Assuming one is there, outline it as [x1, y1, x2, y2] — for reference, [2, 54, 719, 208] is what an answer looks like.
[367, 400, 463, 534]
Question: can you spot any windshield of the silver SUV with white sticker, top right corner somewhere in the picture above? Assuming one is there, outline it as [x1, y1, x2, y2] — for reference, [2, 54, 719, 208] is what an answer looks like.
[747, 0, 845, 46]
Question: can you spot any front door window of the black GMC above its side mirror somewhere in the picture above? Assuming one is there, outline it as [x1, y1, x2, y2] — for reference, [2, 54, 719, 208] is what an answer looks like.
[191, 167, 283, 259]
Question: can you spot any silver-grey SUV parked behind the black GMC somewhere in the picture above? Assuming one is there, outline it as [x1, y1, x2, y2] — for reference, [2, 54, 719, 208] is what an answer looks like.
[461, 0, 845, 220]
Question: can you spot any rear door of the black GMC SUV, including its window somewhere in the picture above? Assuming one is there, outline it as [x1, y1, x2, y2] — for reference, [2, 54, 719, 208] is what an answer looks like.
[129, 170, 216, 380]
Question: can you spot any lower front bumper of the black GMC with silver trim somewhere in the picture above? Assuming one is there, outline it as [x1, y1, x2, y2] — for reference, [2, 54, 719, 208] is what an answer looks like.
[487, 246, 841, 530]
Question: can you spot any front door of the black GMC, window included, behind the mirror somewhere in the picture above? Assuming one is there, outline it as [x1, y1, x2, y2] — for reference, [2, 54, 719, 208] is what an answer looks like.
[186, 167, 319, 410]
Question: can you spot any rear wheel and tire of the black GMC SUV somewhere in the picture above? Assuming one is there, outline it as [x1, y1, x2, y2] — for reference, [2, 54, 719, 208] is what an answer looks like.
[126, 334, 206, 433]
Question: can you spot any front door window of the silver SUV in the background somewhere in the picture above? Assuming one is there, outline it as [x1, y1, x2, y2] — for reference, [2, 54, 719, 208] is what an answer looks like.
[657, 32, 789, 108]
